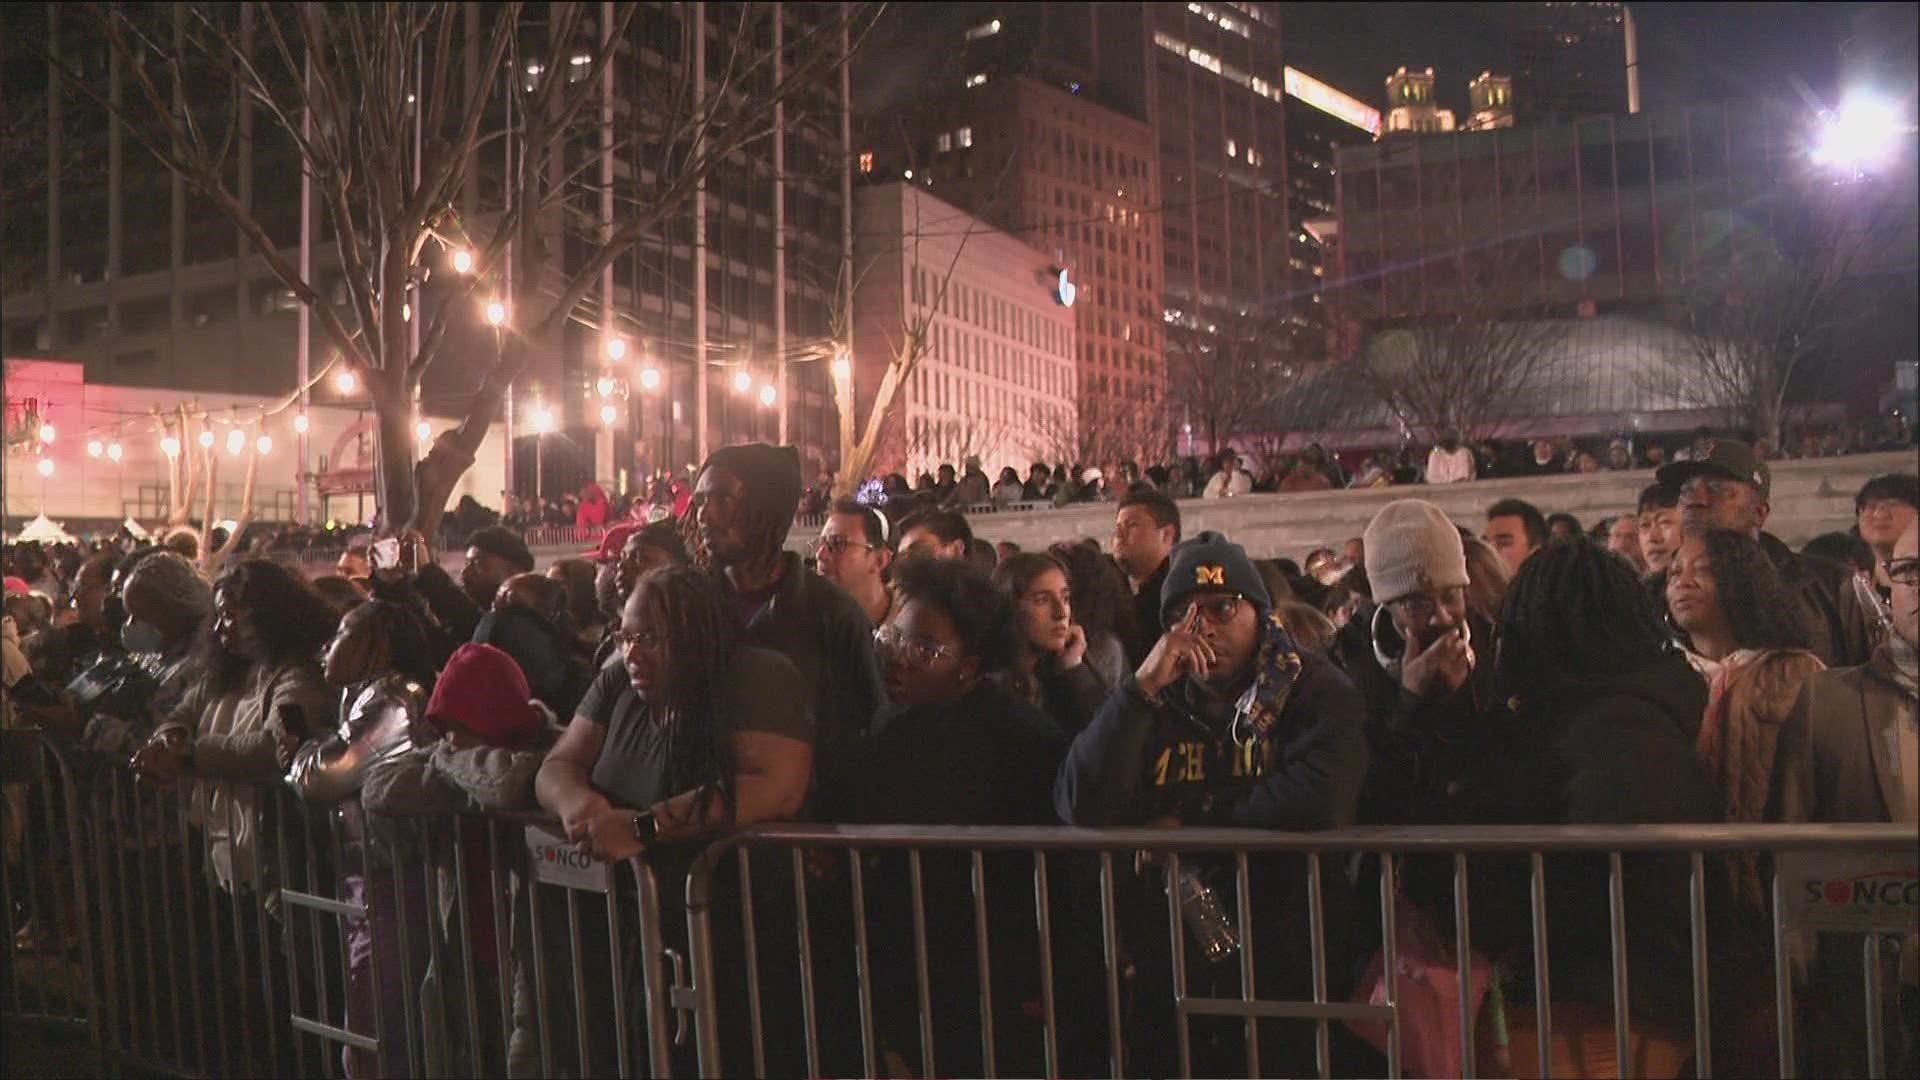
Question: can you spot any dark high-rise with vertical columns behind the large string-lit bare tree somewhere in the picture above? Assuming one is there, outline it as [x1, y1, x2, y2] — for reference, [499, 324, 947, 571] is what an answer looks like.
[0, 4, 851, 503]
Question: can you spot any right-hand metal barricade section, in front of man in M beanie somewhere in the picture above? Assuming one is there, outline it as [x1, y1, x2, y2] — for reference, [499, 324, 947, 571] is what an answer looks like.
[687, 824, 1920, 1076]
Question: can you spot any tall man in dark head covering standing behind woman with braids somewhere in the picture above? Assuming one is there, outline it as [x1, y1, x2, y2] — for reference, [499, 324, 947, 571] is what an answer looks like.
[693, 442, 881, 790]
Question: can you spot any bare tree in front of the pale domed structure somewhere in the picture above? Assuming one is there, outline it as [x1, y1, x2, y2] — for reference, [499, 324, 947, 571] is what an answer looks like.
[1329, 254, 1571, 440]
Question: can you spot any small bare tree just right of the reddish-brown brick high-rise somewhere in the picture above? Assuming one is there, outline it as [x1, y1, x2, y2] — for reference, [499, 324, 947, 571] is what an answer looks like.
[1167, 309, 1325, 450]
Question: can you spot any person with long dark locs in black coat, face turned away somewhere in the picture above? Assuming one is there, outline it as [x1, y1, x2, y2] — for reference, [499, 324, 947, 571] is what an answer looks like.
[1466, 544, 1772, 1076]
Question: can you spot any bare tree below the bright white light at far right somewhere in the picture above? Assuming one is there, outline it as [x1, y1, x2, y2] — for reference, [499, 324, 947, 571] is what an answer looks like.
[1644, 183, 1912, 446]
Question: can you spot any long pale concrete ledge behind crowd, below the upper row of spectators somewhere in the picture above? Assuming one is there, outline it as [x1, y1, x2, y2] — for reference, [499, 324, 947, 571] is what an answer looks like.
[787, 452, 1920, 559]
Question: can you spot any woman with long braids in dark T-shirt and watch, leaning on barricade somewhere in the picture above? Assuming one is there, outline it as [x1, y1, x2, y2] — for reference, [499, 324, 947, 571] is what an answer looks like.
[534, 567, 814, 1074]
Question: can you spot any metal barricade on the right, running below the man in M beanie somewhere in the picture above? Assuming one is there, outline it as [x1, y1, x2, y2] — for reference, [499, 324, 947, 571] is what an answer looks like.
[687, 824, 1920, 1076]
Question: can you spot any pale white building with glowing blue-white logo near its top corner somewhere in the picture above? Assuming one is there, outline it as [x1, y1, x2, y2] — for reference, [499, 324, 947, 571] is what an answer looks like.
[852, 181, 1083, 477]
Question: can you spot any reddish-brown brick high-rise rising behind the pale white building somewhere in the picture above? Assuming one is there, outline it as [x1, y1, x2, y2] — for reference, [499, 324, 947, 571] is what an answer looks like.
[862, 75, 1167, 457]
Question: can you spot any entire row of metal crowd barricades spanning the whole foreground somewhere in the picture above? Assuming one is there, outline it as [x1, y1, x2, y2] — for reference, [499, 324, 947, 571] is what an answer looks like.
[0, 730, 1920, 1076]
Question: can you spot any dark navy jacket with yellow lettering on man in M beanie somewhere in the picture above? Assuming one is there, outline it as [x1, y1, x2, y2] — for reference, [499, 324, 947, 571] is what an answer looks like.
[1054, 651, 1367, 830]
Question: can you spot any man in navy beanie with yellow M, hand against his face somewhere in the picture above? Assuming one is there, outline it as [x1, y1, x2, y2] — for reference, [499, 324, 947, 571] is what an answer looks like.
[1054, 530, 1367, 1074]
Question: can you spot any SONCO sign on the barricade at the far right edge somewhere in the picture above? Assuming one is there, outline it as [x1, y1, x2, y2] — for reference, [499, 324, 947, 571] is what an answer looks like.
[1778, 851, 1920, 934]
